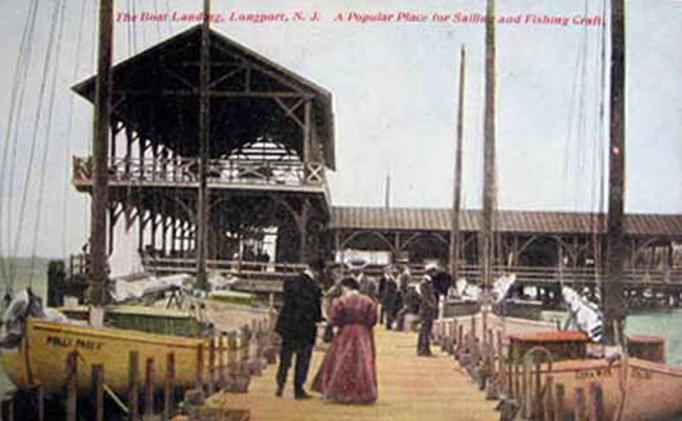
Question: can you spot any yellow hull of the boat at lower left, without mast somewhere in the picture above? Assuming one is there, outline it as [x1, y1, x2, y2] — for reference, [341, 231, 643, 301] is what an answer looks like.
[0, 319, 208, 395]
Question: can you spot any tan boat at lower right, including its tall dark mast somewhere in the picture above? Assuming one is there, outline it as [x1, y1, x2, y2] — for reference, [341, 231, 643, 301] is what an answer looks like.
[496, 0, 682, 420]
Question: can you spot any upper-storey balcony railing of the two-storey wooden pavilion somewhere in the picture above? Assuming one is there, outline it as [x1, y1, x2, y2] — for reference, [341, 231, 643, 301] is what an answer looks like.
[73, 157, 327, 187]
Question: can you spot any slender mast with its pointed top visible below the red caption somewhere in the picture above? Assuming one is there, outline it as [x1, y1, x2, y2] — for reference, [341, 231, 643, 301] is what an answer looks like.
[450, 46, 466, 282]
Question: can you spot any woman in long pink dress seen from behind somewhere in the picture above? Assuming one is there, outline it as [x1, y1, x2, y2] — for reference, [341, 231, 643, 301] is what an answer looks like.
[319, 278, 377, 403]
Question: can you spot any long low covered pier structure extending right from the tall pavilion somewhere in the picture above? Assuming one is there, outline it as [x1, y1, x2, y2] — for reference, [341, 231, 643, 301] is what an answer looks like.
[330, 207, 682, 307]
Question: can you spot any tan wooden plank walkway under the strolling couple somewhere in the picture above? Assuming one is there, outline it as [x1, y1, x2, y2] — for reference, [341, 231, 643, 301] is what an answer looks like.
[202, 326, 499, 421]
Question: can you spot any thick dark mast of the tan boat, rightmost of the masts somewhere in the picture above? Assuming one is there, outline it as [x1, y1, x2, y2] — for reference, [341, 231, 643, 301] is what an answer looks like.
[602, 0, 625, 344]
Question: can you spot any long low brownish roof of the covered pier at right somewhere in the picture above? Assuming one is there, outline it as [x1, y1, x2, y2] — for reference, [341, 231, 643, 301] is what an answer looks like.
[330, 206, 682, 238]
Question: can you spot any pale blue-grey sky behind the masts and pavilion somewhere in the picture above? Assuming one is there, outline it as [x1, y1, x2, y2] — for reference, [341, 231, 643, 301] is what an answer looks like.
[0, 0, 682, 257]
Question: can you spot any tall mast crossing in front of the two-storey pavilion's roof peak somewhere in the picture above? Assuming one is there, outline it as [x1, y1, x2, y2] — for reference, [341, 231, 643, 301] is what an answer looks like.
[196, 0, 211, 289]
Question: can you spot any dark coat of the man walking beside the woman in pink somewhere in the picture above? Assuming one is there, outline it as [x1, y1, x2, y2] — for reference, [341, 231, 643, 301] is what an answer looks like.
[275, 274, 322, 345]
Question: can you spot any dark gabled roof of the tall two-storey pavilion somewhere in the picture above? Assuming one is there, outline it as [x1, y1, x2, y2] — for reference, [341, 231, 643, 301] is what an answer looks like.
[73, 25, 335, 169]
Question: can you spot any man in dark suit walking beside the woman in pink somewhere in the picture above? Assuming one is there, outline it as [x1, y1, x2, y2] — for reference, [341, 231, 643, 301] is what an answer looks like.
[275, 267, 322, 399]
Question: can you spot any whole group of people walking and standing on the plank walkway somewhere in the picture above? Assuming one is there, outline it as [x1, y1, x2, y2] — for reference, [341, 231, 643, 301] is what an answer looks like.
[275, 265, 447, 404]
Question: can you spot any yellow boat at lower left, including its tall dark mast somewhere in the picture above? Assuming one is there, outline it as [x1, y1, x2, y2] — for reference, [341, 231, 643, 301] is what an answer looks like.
[0, 1, 226, 395]
